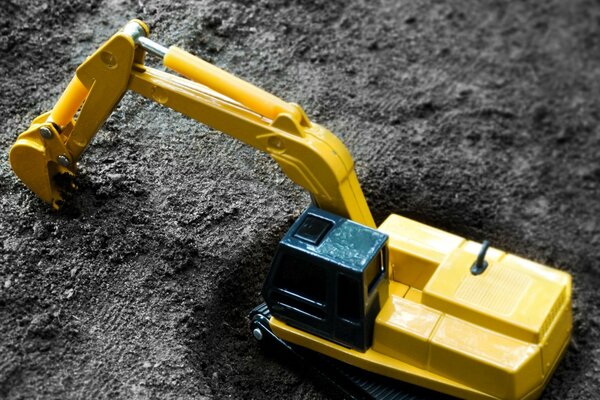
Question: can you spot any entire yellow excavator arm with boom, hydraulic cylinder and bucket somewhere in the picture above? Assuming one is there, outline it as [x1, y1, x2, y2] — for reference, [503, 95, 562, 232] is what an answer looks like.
[10, 20, 375, 227]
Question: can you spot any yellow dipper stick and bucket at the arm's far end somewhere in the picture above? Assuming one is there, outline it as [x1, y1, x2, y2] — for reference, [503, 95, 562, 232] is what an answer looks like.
[9, 26, 140, 209]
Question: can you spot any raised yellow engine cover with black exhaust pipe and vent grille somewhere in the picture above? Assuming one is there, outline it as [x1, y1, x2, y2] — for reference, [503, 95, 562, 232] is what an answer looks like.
[422, 248, 570, 342]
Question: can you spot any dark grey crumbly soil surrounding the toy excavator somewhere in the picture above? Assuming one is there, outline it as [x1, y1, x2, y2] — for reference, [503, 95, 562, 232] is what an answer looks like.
[0, 0, 600, 400]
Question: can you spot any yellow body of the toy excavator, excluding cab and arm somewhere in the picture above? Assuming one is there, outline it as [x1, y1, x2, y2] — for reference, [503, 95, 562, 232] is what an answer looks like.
[271, 215, 572, 399]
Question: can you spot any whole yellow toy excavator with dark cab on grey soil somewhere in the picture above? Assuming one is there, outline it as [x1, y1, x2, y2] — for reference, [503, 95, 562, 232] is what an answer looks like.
[10, 20, 572, 399]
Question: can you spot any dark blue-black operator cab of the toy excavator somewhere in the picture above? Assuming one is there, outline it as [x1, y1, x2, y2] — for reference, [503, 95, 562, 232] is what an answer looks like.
[263, 207, 388, 351]
